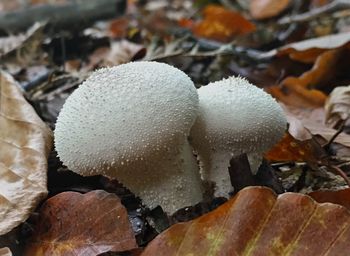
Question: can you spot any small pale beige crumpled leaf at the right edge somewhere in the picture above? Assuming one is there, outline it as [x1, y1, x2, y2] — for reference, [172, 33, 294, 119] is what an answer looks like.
[324, 86, 350, 125]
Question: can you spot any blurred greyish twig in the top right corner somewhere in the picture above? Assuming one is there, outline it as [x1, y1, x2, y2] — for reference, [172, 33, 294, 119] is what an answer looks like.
[277, 0, 350, 25]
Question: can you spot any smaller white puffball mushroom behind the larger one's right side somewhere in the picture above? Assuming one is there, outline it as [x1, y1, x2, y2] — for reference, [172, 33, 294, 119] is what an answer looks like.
[190, 77, 287, 197]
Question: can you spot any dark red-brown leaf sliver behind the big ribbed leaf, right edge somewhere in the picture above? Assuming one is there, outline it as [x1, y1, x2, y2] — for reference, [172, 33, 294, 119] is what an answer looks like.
[308, 188, 350, 210]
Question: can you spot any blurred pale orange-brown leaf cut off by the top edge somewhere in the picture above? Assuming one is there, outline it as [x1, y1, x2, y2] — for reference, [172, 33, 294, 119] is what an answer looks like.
[249, 0, 291, 20]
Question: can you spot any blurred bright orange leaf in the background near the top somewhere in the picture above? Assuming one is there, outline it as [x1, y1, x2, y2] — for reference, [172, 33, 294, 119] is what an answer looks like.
[192, 5, 255, 42]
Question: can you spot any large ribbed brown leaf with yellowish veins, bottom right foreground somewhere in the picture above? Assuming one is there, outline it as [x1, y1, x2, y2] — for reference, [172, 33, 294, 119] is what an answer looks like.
[141, 187, 350, 256]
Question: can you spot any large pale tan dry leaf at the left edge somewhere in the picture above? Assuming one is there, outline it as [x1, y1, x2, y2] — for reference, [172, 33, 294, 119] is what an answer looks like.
[0, 71, 52, 235]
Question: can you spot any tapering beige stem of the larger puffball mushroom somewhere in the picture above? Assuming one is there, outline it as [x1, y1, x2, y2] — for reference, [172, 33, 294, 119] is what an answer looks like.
[117, 140, 203, 214]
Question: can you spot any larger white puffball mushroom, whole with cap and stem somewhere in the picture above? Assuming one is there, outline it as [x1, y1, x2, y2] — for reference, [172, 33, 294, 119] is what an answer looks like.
[55, 62, 202, 213]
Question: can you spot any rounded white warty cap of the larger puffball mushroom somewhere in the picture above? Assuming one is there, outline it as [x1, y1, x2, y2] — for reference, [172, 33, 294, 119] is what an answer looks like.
[55, 61, 198, 177]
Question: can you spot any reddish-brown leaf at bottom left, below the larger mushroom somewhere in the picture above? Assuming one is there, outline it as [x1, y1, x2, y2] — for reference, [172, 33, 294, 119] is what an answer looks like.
[25, 190, 137, 256]
